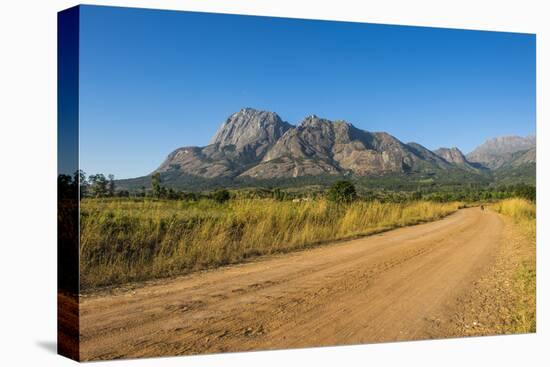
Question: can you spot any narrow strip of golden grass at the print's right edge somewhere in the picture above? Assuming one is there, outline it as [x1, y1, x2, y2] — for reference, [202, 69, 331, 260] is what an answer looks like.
[494, 199, 537, 333]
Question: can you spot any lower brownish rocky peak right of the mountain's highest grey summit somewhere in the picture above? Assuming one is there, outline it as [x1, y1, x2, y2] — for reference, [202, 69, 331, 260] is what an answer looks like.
[242, 115, 462, 178]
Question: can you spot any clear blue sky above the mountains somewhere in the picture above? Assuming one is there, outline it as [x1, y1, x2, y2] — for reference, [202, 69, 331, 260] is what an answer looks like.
[80, 6, 535, 178]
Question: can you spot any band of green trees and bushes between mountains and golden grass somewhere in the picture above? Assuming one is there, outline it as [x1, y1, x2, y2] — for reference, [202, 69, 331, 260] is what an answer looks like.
[88, 170, 536, 203]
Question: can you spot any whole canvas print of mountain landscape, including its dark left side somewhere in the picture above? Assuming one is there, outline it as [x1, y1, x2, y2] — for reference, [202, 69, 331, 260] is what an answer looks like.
[58, 6, 536, 361]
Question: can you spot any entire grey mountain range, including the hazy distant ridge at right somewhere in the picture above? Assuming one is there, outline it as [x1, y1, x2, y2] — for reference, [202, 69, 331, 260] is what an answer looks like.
[121, 108, 536, 190]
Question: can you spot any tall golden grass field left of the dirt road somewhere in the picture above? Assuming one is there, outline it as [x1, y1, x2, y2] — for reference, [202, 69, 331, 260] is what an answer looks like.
[80, 199, 459, 291]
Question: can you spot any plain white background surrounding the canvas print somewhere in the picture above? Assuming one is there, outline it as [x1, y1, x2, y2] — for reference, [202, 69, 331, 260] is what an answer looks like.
[0, 0, 550, 367]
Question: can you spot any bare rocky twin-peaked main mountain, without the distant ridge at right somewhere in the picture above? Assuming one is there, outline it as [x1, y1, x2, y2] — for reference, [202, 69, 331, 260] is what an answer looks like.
[155, 108, 474, 179]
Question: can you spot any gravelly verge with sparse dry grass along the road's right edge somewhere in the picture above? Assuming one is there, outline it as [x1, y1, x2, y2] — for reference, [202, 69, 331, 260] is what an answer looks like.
[432, 214, 536, 338]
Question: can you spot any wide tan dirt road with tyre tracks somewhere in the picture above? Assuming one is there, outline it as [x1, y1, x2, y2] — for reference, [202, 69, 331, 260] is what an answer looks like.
[80, 208, 507, 360]
